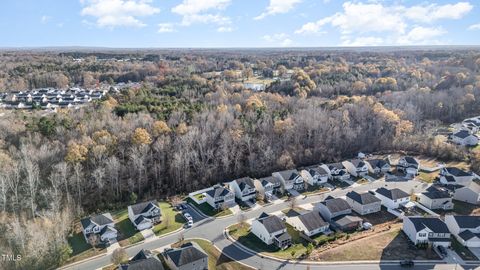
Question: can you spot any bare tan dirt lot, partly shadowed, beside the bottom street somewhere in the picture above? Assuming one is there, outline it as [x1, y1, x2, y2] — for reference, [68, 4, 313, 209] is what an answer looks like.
[309, 224, 439, 261]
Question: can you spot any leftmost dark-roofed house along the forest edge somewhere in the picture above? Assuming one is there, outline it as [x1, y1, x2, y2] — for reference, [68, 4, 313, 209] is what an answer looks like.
[80, 213, 117, 243]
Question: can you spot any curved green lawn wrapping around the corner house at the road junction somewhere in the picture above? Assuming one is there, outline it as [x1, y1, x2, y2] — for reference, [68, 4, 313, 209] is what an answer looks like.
[228, 221, 307, 260]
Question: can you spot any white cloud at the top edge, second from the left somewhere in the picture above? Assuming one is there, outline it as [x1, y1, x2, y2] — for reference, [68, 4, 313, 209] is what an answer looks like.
[172, 0, 231, 26]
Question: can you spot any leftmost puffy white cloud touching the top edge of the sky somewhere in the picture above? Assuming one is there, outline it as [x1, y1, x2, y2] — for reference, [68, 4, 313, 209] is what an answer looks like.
[80, 0, 160, 28]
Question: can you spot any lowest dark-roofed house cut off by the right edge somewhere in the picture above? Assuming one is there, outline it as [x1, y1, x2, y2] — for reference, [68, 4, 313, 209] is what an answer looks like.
[445, 215, 480, 248]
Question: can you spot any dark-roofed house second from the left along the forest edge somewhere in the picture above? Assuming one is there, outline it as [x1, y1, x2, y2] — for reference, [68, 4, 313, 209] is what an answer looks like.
[128, 201, 162, 231]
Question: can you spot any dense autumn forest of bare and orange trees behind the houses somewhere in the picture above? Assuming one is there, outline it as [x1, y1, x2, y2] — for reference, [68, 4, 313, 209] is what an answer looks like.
[0, 49, 480, 269]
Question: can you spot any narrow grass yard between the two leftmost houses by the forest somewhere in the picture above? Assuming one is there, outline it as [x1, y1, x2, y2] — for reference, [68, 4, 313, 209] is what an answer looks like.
[113, 209, 144, 247]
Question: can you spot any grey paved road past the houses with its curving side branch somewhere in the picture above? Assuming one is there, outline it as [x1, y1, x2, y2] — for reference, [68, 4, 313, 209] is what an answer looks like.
[62, 180, 446, 270]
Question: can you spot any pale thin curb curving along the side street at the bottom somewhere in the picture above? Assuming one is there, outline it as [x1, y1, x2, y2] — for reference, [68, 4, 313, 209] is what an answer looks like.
[224, 229, 446, 265]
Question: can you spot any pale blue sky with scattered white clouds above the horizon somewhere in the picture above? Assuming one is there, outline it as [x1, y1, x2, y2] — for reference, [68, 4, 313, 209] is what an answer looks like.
[0, 0, 480, 48]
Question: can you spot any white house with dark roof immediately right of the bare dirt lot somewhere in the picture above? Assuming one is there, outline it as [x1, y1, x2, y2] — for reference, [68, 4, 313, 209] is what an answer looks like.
[402, 216, 451, 247]
